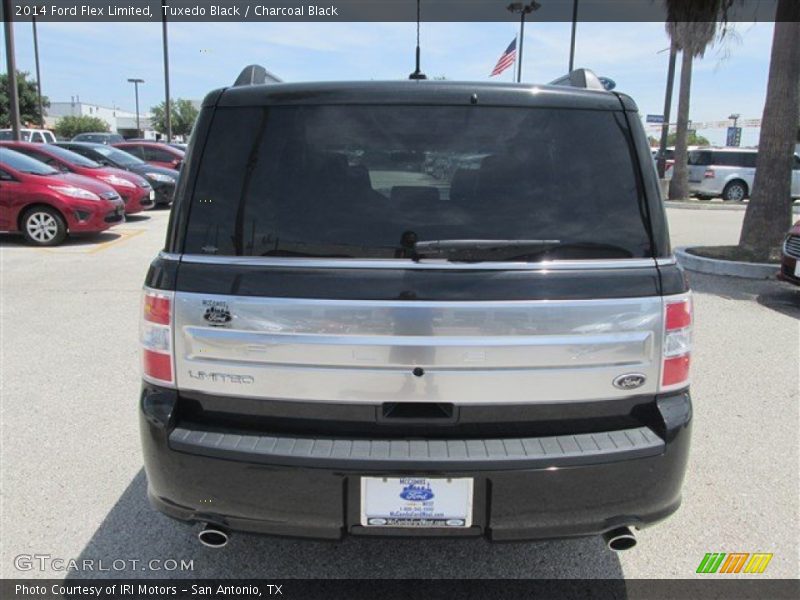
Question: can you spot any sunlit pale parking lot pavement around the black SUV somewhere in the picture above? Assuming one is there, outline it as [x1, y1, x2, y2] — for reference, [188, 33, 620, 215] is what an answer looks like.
[0, 209, 800, 578]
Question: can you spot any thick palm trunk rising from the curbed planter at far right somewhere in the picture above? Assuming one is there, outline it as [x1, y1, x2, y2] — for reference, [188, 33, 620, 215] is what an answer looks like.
[736, 0, 800, 261]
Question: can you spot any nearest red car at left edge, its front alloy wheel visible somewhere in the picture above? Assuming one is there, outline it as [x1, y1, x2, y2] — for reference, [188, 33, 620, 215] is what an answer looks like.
[0, 148, 125, 246]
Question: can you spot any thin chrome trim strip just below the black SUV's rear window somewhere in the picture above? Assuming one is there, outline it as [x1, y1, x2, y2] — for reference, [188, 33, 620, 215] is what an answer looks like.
[178, 253, 664, 271]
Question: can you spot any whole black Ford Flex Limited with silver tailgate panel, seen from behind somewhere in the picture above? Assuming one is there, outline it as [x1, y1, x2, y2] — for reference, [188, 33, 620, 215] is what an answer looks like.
[140, 69, 692, 549]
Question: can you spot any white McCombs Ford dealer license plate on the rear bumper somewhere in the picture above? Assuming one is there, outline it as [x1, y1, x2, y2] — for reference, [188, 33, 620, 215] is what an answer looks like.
[361, 477, 473, 528]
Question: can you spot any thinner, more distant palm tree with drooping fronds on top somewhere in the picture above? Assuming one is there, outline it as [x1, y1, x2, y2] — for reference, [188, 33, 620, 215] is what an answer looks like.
[666, 0, 734, 200]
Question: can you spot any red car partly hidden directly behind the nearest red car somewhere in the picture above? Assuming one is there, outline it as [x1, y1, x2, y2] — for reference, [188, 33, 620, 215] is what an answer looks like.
[0, 142, 155, 215]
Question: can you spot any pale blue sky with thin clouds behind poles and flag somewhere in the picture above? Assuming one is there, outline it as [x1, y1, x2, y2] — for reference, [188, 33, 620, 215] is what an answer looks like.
[2, 22, 773, 145]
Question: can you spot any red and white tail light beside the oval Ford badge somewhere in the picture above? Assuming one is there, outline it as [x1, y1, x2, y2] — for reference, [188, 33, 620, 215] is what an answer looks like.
[661, 296, 692, 392]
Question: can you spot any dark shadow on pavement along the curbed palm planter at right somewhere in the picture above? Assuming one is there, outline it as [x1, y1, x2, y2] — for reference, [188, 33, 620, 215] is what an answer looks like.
[689, 267, 800, 319]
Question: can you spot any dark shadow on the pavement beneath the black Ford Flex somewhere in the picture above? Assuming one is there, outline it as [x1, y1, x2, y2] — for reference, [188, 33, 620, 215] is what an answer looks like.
[68, 469, 625, 584]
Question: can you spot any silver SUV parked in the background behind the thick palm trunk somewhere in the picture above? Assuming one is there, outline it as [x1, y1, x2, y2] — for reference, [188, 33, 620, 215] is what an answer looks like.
[689, 148, 800, 202]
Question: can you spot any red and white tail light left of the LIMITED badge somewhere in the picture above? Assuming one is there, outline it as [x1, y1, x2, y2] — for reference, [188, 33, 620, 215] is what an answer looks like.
[140, 288, 175, 386]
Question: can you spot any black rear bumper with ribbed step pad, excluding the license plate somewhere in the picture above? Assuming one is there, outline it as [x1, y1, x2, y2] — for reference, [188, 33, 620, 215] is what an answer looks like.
[140, 386, 691, 541]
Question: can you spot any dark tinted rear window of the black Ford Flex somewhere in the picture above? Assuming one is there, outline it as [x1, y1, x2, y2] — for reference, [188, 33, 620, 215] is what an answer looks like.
[184, 105, 652, 261]
